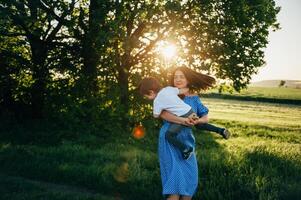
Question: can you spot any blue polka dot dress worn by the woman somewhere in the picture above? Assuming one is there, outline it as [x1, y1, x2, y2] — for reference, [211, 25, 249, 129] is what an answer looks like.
[158, 96, 208, 197]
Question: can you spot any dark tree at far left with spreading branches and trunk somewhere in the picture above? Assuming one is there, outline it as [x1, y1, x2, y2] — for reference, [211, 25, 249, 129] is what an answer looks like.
[0, 0, 76, 117]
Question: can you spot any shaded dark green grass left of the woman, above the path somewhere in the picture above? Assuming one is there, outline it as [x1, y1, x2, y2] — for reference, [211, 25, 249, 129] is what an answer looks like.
[0, 132, 161, 199]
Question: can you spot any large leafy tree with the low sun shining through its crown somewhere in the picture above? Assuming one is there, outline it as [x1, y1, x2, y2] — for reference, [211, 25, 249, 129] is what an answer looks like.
[91, 0, 279, 114]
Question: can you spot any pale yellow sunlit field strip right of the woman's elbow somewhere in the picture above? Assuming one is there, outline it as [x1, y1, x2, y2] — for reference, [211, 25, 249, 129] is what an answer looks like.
[202, 98, 301, 129]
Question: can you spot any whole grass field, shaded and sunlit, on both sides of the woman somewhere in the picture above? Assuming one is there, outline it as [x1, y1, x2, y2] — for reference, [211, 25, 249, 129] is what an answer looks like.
[0, 88, 301, 200]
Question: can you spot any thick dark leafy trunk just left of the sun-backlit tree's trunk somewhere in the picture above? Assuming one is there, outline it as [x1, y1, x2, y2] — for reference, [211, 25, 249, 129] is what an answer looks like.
[73, 0, 112, 96]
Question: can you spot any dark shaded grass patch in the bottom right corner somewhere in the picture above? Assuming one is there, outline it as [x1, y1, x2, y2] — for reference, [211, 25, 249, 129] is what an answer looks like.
[242, 147, 301, 200]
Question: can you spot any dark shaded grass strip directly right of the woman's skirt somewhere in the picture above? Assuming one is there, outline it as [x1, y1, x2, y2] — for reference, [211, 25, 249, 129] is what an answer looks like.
[194, 130, 231, 199]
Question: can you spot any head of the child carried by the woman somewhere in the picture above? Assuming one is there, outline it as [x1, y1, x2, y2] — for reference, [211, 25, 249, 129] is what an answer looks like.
[138, 77, 161, 100]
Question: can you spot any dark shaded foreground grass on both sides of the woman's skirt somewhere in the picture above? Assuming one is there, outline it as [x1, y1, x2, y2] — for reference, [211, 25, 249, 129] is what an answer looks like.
[0, 125, 301, 200]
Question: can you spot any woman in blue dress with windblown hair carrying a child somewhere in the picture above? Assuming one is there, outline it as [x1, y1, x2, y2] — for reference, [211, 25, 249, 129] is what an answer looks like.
[159, 67, 229, 200]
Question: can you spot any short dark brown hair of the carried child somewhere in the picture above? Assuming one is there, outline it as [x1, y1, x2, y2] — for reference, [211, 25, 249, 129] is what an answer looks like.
[138, 77, 161, 95]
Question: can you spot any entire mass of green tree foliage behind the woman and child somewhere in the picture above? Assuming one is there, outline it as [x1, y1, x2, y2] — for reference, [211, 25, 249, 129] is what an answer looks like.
[0, 0, 279, 129]
